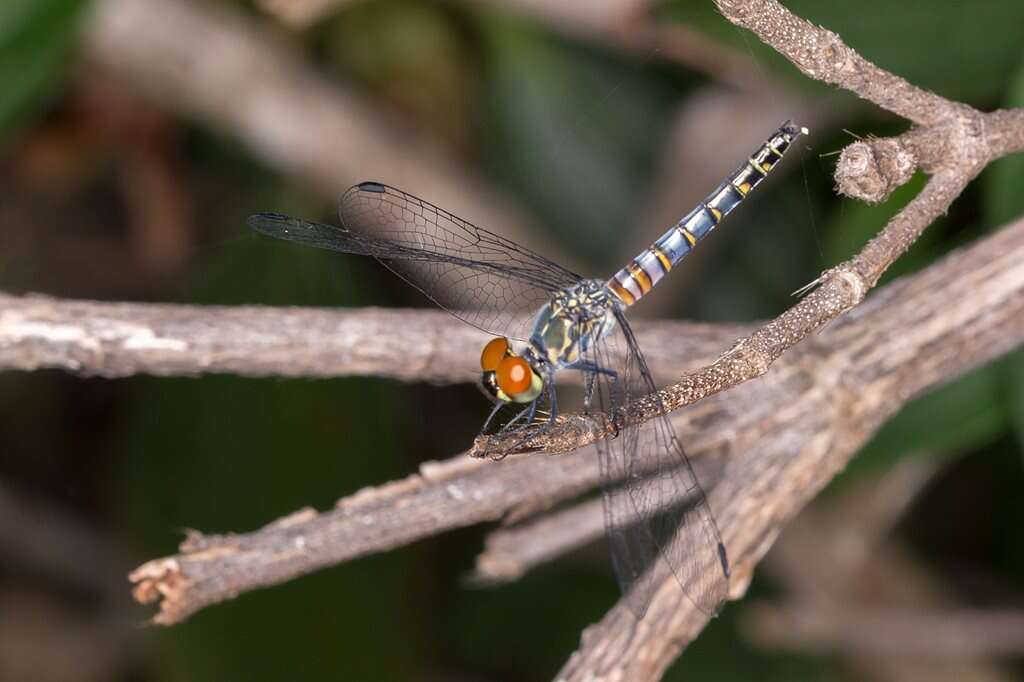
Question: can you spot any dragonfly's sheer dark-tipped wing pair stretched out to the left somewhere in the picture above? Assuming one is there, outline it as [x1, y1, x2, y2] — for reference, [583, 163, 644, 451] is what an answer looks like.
[249, 182, 581, 340]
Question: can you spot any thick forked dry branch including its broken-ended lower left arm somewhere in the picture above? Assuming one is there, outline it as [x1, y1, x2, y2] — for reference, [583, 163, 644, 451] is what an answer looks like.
[132, 214, 1024, 626]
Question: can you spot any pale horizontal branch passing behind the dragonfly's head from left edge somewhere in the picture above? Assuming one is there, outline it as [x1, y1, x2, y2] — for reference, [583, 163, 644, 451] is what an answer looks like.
[0, 293, 745, 383]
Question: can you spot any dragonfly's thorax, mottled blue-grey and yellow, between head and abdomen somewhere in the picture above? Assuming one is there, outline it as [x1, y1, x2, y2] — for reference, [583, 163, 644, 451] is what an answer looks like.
[529, 280, 615, 370]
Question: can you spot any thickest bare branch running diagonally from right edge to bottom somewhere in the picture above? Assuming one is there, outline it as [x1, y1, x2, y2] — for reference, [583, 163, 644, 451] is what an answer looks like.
[560, 221, 1024, 680]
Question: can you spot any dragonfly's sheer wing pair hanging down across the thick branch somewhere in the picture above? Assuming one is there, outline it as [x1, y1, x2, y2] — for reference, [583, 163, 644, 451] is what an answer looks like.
[591, 312, 729, 617]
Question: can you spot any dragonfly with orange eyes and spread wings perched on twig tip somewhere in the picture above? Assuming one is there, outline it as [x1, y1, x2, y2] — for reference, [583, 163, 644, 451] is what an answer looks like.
[248, 121, 807, 619]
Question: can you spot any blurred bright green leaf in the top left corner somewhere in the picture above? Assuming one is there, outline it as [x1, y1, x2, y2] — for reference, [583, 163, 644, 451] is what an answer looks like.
[0, 0, 87, 139]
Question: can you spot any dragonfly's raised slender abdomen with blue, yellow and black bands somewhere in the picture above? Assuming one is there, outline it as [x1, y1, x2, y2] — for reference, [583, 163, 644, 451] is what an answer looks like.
[607, 121, 807, 305]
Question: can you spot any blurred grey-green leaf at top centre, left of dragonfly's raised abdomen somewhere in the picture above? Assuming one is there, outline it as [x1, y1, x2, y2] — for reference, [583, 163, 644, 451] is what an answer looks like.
[481, 16, 677, 267]
